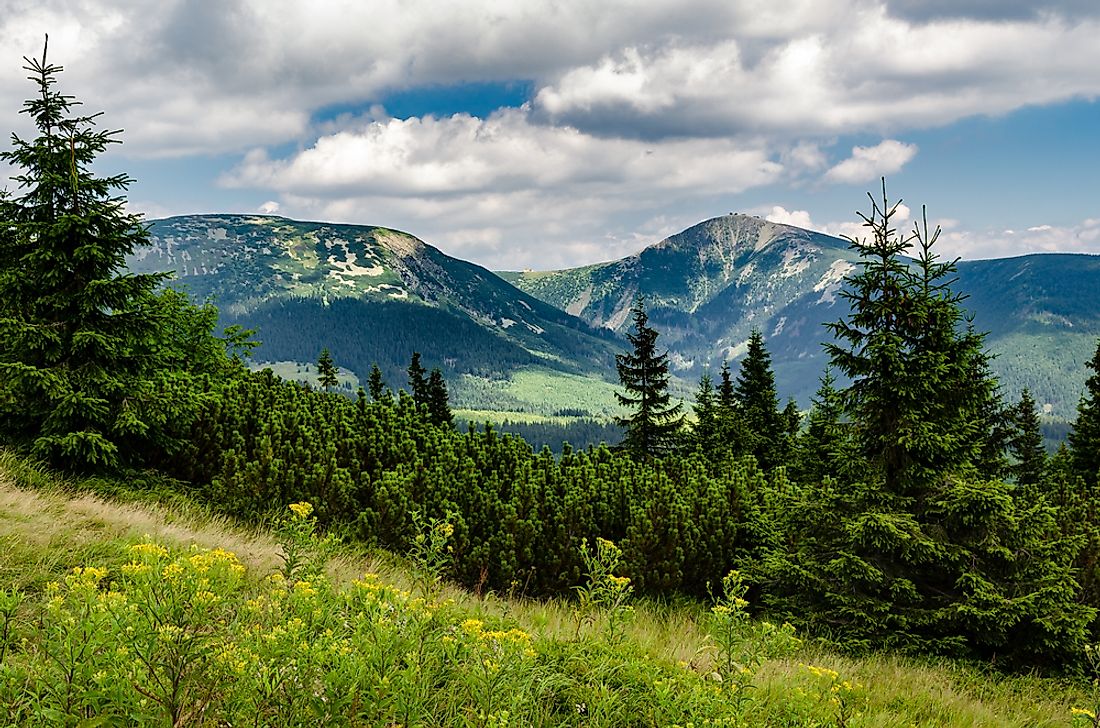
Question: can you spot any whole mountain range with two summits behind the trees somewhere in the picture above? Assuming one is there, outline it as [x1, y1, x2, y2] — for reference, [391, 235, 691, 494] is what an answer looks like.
[130, 214, 1100, 419]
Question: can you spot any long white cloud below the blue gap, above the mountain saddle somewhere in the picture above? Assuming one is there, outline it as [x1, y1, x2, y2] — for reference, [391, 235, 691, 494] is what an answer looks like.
[223, 109, 783, 267]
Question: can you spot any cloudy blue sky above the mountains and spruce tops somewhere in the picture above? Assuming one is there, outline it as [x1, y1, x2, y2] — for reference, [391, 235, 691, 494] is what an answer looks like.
[0, 0, 1100, 269]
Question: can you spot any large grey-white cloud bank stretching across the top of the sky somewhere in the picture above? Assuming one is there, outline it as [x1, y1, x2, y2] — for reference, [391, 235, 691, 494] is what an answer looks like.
[0, 0, 1100, 155]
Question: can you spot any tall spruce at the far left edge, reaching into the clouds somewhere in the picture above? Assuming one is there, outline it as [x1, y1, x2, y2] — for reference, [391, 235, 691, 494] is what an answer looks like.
[0, 38, 226, 471]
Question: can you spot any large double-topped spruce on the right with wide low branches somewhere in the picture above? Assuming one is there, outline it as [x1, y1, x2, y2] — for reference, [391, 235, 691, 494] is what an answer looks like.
[757, 184, 1092, 661]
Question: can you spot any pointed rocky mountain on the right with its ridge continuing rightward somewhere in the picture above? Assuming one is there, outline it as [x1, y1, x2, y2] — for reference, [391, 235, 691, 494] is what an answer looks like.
[501, 214, 1100, 419]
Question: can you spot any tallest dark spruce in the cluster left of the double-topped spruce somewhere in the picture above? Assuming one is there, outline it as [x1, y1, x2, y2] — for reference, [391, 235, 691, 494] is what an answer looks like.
[734, 329, 787, 470]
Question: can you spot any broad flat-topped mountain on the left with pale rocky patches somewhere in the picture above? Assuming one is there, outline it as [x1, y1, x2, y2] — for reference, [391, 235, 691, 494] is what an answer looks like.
[129, 214, 622, 413]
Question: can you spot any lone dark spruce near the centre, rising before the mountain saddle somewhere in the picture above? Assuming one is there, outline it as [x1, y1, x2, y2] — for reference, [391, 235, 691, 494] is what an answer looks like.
[615, 296, 684, 455]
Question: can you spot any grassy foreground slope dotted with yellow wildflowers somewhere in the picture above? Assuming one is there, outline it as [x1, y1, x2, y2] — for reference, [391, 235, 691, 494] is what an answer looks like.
[0, 451, 1091, 728]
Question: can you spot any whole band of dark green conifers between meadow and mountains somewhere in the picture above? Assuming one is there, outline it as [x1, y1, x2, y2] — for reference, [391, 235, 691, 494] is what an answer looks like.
[0, 42, 1100, 665]
